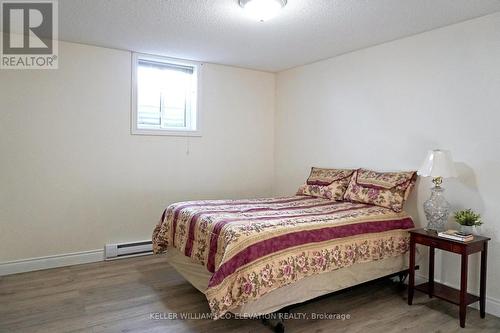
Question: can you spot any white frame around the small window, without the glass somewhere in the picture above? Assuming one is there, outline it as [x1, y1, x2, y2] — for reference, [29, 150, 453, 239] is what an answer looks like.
[131, 52, 203, 137]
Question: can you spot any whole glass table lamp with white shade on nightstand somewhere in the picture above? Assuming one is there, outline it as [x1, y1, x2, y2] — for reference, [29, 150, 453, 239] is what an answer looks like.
[417, 149, 457, 231]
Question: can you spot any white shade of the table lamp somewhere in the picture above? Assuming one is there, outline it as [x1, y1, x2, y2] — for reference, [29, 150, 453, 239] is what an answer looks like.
[418, 149, 457, 178]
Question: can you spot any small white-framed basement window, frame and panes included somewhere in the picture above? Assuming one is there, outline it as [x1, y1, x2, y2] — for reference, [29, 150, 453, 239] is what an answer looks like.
[132, 54, 200, 136]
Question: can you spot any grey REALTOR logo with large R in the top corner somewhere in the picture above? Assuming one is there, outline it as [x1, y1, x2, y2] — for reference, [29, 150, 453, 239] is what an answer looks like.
[0, 0, 58, 69]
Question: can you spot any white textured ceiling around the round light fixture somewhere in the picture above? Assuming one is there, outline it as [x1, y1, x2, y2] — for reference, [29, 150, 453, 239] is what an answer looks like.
[59, 0, 500, 72]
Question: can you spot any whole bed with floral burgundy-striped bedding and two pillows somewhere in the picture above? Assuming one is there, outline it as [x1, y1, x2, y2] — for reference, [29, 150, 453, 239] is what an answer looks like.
[153, 168, 416, 319]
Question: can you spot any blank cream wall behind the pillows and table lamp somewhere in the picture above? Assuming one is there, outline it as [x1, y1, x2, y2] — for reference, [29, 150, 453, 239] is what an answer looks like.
[275, 13, 500, 311]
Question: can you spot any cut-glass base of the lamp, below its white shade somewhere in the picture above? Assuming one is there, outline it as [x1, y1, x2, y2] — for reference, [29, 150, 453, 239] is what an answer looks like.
[424, 186, 451, 231]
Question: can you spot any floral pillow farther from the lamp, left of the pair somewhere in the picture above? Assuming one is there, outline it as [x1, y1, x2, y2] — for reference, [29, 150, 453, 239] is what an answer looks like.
[297, 168, 354, 201]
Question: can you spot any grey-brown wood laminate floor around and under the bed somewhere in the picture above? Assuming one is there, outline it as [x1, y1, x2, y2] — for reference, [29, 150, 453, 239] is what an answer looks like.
[0, 256, 500, 333]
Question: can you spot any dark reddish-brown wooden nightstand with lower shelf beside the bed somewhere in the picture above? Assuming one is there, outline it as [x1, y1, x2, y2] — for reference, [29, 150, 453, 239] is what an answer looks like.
[408, 229, 490, 327]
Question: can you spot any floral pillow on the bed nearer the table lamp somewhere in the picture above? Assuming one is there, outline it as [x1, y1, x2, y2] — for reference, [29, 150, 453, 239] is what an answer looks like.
[344, 169, 417, 212]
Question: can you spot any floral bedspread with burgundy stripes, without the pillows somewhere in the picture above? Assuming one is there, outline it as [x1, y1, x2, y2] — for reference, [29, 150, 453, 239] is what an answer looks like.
[153, 196, 414, 318]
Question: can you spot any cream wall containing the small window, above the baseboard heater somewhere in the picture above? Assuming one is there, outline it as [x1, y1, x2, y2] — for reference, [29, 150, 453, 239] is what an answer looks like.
[0, 43, 275, 263]
